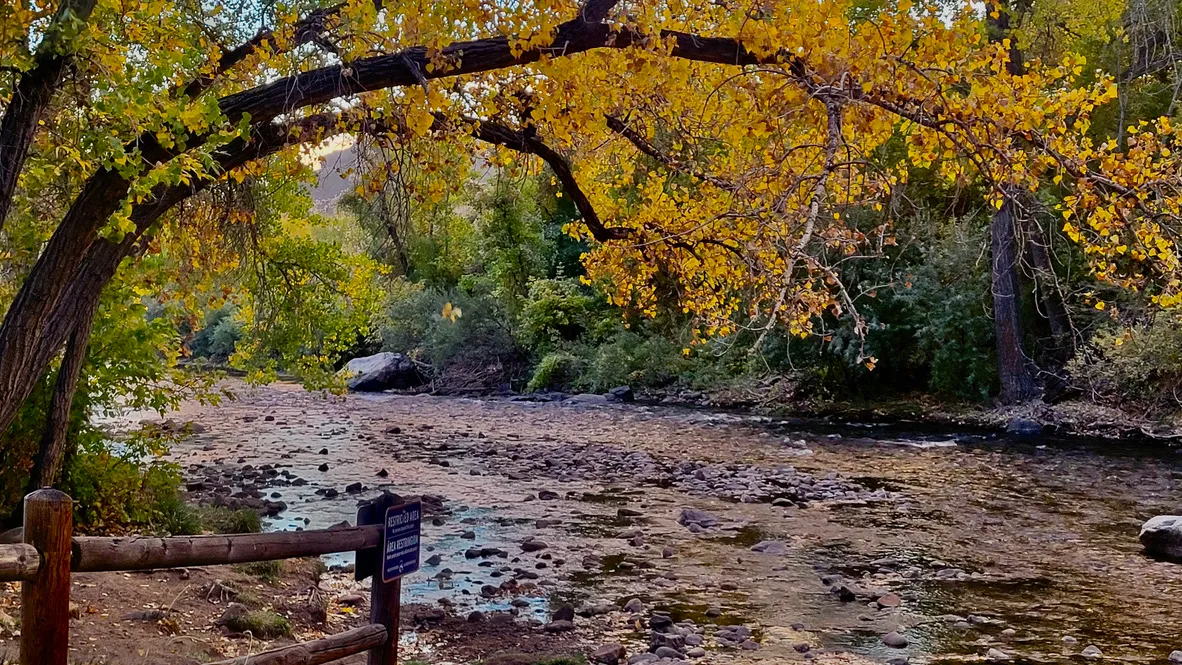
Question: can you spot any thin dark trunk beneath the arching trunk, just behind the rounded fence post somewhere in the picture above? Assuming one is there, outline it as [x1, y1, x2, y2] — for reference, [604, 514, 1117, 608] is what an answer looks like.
[28, 298, 98, 493]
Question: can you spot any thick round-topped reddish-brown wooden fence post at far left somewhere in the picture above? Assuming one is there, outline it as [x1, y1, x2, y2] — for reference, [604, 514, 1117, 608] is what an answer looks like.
[20, 489, 73, 665]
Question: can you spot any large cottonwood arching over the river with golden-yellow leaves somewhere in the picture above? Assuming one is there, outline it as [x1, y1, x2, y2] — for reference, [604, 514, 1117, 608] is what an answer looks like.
[0, 0, 1180, 484]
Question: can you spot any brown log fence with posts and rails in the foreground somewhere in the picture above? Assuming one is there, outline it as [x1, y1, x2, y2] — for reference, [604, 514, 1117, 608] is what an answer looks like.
[0, 489, 402, 665]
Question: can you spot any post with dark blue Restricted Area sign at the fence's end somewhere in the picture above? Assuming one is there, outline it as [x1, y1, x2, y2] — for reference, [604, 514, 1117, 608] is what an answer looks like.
[356, 494, 423, 665]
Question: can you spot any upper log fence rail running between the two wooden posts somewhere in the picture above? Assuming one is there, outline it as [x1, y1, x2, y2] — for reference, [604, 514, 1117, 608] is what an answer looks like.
[70, 524, 382, 573]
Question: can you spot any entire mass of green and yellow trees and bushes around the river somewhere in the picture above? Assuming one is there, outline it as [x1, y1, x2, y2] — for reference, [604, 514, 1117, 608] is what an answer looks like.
[0, 0, 1182, 529]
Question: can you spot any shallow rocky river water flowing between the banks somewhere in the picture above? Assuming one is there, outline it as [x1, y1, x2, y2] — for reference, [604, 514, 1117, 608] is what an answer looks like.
[161, 385, 1182, 663]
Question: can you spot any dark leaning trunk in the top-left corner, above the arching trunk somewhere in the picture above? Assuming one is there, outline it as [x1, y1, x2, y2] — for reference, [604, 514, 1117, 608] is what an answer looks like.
[0, 0, 97, 228]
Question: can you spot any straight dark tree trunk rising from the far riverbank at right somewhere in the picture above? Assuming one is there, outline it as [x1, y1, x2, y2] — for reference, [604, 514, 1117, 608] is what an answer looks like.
[989, 196, 1040, 404]
